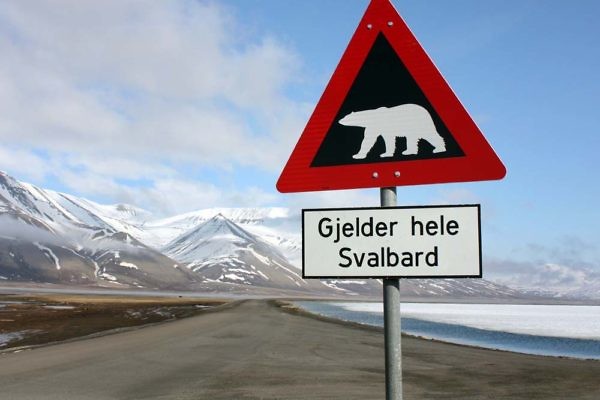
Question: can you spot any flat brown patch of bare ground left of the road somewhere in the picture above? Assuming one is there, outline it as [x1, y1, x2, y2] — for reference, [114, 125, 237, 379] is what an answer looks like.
[0, 295, 225, 351]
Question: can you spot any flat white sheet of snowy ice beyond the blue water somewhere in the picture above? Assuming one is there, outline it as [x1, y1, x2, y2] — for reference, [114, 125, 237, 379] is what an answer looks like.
[333, 303, 600, 340]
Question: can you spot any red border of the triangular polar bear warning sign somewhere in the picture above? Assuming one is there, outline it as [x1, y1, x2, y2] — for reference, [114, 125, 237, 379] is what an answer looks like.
[277, 0, 506, 193]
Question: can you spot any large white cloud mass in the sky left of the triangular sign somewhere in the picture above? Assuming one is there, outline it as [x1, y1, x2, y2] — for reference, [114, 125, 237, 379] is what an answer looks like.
[0, 0, 308, 210]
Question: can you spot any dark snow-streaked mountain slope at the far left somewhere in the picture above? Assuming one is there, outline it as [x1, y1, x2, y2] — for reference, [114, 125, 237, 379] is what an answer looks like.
[0, 172, 195, 289]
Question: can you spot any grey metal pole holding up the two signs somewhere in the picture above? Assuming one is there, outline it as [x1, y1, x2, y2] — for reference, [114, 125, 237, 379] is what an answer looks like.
[380, 187, 402, 400]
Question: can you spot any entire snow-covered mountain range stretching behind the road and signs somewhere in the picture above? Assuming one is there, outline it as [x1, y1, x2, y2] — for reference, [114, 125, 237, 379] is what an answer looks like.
[0, 172, 540, 297]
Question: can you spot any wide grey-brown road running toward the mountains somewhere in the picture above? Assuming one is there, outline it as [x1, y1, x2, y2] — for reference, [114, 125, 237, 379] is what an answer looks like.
[0, 301, 600, 400]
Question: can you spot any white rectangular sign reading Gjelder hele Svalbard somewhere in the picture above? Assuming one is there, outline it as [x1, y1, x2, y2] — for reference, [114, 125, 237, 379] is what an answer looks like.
[302, 204, 481, 278]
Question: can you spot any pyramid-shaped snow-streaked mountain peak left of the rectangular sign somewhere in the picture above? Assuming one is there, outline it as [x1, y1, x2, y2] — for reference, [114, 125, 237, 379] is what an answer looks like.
[163, 214, 376, 294]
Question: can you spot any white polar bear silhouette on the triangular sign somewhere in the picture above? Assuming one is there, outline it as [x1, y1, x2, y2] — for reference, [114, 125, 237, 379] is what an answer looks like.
[338, 104, 446, 159]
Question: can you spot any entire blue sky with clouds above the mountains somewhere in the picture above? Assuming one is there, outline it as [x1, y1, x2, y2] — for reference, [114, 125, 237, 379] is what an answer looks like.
[0, 0, 600, 288]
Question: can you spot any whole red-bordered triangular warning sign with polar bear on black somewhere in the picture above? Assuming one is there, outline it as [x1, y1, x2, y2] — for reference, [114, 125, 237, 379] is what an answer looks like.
[277, 0, 506, 193]
